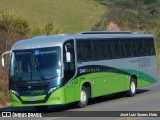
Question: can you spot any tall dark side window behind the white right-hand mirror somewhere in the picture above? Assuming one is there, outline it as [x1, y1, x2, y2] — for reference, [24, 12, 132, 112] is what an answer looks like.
[63, 40, 75, 82]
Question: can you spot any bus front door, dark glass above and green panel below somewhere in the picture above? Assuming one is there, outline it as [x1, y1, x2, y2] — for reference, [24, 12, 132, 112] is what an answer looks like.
[63, 40, 75, 103]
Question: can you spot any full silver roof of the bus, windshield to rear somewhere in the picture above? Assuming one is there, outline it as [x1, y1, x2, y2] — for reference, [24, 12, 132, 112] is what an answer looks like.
[12, 31, 153, 50]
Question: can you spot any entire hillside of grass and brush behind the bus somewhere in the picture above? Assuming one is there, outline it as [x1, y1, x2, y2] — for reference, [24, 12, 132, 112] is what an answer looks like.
[0, 0, 160, 105]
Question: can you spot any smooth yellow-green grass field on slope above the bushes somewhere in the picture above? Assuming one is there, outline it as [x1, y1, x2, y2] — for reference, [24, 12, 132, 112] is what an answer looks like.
[0, 0, 105, 33]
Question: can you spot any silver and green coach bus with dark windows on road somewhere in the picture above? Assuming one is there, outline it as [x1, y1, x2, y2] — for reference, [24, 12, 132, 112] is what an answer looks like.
[2, 31, 157, 110]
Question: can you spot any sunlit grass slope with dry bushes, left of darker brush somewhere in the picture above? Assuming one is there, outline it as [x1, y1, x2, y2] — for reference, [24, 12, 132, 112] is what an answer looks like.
[0, 0, 105, 105]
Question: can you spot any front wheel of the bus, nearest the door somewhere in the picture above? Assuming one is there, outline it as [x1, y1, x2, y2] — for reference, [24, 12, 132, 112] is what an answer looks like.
[77, 86, 88, 108]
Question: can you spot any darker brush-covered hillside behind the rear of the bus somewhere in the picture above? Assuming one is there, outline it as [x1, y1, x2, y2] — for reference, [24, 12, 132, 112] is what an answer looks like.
[93, 0, 160, 64]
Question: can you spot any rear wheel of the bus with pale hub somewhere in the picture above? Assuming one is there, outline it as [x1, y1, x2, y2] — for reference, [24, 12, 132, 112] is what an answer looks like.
[127, 78, 136, 97]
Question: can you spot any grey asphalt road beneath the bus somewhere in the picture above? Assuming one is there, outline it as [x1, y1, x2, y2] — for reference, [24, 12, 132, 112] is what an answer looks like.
[0, 81, 160, 120]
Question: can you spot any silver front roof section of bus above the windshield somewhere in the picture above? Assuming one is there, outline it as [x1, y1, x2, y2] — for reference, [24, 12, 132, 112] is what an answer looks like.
[12, 34, 73, 50]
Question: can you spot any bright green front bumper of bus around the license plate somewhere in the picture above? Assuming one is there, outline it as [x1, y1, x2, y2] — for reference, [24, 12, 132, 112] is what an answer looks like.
[9, 87, 65, 107]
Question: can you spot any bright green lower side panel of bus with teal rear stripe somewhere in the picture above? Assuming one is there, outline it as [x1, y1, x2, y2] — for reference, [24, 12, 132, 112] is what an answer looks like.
[71, 69, 156, 103]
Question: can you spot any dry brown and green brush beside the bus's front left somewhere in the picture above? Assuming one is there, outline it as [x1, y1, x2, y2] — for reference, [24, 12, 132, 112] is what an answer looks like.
[0, 11, 62, 105]
